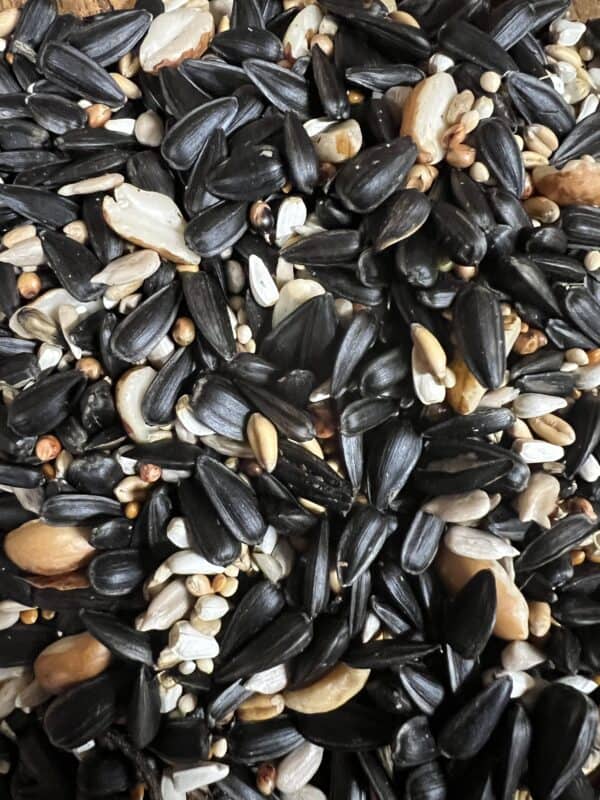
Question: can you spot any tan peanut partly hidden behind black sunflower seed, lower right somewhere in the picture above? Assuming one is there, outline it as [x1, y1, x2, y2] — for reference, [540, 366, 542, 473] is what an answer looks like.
[436, 546, 529, 641]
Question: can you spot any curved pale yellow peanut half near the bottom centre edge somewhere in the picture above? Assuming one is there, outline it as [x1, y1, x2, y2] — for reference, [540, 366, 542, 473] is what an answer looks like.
[283, 662, 371, 714]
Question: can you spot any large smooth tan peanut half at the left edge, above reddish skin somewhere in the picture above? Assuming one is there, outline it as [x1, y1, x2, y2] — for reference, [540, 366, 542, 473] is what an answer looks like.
[4, 519, 96, 575]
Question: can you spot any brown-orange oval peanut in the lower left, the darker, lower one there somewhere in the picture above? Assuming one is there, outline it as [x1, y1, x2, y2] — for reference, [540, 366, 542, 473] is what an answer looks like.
[33, 633, 111, 694]
